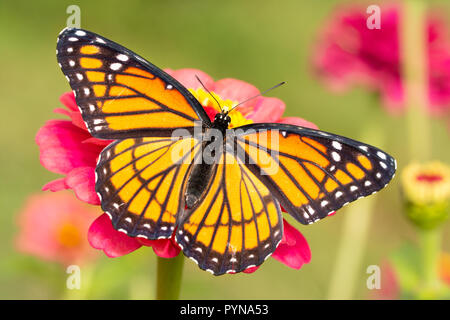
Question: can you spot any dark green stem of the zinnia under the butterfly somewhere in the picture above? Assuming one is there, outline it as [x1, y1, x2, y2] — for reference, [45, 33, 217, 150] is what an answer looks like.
[156, 253, 184, 300]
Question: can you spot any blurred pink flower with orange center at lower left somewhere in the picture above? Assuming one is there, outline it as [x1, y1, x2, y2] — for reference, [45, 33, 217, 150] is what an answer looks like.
[16, 193, 99, 265]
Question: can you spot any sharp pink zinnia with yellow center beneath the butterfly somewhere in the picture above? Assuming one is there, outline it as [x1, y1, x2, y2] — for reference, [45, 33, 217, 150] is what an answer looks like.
[36, 69, 317, 272]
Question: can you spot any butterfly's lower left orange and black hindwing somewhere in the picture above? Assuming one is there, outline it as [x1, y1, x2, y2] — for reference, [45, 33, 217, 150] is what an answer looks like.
[95, 137, 200, 240]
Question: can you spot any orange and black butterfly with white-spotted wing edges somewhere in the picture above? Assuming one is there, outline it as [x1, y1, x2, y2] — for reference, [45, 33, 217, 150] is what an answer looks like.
[57, 28, 396, 275]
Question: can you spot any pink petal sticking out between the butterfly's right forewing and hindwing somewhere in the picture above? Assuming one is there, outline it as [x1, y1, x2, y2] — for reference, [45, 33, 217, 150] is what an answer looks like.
[272, 219, 311, 269]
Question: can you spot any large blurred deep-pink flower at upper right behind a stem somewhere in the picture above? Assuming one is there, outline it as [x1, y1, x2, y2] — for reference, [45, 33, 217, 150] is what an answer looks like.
[313, 5, 450, 114]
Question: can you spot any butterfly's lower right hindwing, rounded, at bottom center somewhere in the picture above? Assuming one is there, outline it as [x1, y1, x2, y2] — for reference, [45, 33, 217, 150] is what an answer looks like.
[175, 146, 283, 275]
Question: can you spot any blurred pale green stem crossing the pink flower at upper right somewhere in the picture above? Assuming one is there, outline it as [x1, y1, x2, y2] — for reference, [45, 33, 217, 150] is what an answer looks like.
[400, 0, 431, 161]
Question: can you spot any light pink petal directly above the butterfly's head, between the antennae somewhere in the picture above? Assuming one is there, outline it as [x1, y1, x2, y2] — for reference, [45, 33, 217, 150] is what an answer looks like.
[214, 78, 259, 110]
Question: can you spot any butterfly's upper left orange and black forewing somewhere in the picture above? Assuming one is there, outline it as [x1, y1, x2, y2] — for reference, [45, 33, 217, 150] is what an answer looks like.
[56, 28, 211, 139]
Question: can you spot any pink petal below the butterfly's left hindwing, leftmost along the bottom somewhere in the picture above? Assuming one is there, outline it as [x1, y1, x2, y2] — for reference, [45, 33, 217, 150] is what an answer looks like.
[88, 213, 142, 258]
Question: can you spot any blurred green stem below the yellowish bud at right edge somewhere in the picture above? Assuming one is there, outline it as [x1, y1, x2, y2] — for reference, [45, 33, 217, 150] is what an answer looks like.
[419, 228, 442, 298]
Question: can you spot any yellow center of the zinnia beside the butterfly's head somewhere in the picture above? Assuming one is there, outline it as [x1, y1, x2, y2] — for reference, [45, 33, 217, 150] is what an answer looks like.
[189, 88, 253, 128]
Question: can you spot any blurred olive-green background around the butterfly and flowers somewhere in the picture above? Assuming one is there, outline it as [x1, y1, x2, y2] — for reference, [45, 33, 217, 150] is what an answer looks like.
[0, 0, 450, 299]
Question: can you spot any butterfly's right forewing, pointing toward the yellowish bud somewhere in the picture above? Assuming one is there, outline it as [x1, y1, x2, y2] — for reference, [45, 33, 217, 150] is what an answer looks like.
[234, 124, 396, 224]
